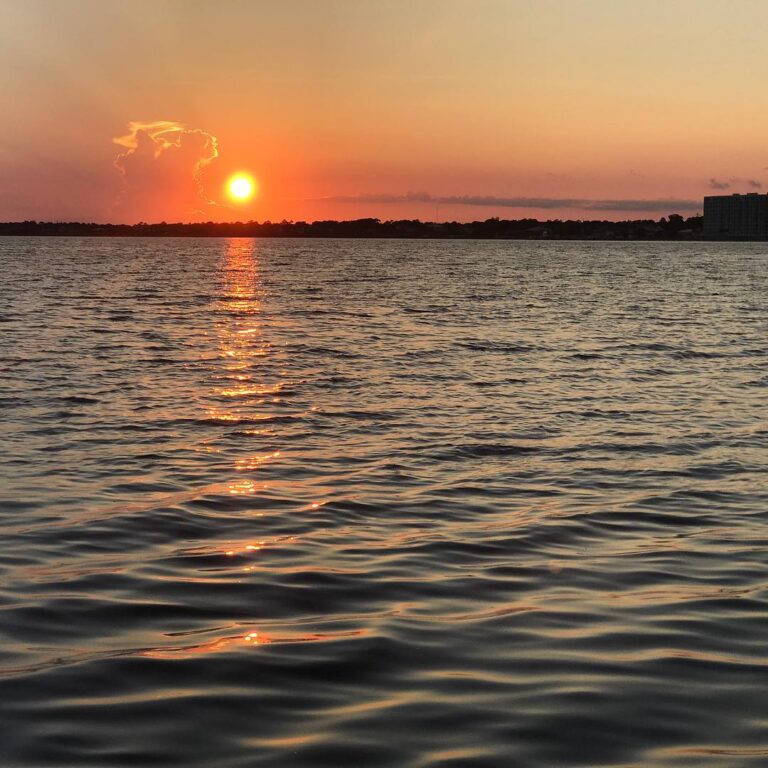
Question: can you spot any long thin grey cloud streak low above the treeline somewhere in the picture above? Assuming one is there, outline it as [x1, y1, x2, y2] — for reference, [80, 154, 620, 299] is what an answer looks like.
[314, 192, 701, 212]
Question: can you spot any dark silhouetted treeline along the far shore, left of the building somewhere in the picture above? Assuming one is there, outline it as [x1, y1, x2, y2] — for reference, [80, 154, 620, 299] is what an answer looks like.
[0, 214, 703, 240]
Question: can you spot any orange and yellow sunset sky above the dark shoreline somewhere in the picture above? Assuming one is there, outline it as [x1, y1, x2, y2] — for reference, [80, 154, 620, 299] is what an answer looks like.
[0, 0, 768, 222]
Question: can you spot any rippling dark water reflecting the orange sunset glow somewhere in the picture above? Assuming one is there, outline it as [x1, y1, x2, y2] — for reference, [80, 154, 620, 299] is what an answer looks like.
[0, 239, 768, 768]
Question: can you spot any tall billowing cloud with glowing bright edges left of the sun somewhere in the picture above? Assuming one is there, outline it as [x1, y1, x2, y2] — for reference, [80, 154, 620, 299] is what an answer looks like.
[112, 120, 219, 221]
